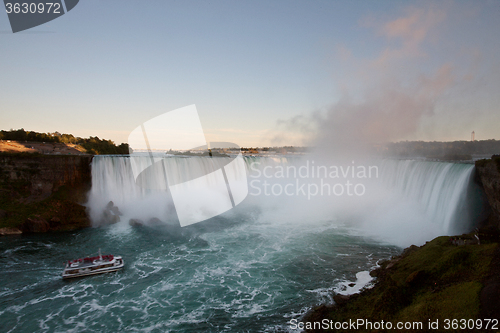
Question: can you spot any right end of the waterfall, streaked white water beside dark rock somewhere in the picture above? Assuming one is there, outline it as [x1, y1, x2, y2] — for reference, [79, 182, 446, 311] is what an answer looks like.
[381, 160, 484, 234]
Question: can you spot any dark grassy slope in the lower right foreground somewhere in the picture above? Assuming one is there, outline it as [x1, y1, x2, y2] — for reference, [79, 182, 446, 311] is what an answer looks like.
[304, 236, 498, 332]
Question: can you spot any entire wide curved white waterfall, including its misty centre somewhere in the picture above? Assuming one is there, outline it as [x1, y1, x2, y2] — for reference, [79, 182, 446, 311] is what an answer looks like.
[88, 156, 483, 246]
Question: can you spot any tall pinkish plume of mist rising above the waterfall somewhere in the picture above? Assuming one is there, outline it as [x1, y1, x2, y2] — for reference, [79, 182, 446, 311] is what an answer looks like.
[275, 5, 461, 154]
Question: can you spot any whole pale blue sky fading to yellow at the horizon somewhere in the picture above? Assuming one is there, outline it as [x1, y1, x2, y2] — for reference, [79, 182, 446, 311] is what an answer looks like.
[0, 0, 500, 147]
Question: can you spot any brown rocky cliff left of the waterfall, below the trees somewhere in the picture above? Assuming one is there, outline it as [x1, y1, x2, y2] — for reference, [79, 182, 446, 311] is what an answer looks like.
[0, 153, 92, 234]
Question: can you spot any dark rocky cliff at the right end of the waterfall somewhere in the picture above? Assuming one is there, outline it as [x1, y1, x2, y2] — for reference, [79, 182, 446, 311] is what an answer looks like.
[476, 155, 500, 229]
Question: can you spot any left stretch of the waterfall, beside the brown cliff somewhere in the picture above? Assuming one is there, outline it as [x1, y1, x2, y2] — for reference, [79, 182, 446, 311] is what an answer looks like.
[88, 156, 246, 225]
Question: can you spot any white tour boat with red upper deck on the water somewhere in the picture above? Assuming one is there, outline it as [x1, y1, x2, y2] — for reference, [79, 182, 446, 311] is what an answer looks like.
[63, 250, 124, 279]
